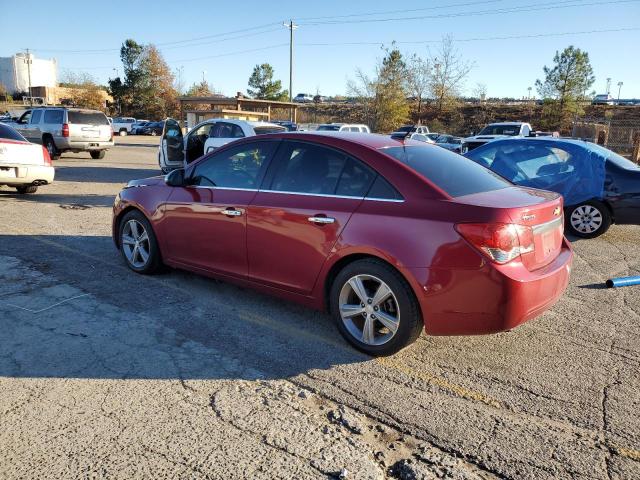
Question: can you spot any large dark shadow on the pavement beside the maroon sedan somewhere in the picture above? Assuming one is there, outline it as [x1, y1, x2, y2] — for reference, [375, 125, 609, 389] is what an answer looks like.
[0, 235, 370, 380]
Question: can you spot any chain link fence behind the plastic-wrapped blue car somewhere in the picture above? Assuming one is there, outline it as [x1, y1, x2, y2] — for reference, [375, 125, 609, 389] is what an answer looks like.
[571, 117, 640, 162]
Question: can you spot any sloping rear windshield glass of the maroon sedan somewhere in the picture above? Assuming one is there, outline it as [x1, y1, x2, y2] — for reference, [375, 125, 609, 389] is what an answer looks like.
[381, 145, 512, 197]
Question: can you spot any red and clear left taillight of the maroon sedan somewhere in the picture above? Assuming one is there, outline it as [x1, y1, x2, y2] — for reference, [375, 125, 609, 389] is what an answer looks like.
[456, 223, 535, 264]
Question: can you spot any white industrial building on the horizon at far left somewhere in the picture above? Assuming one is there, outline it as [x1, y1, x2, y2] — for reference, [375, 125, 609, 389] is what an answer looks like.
[0, 53, 58, 93]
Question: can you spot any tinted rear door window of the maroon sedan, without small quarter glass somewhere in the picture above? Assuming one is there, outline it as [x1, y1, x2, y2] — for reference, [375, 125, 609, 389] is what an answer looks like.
[271, 142, 347, 195]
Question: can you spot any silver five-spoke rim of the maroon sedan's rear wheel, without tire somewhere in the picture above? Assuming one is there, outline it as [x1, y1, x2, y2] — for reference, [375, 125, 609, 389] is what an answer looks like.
[338, 275, 400, 345]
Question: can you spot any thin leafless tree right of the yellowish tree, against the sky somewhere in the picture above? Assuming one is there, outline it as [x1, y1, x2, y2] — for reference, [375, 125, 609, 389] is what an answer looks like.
[429, 36, 473, 113]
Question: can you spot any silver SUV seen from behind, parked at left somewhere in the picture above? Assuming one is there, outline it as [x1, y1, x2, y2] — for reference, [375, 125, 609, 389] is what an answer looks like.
[12, 107, 113, 159]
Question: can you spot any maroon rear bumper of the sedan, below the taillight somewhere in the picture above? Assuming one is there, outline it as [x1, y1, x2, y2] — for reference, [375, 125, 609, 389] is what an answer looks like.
[410, 239, 573, 335]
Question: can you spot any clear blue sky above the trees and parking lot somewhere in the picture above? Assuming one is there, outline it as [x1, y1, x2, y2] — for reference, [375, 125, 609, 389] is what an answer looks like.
[0, 0, 640, 98]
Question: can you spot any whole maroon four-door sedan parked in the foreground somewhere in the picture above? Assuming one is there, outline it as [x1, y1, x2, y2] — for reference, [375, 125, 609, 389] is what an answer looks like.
[113, 133, 572, 355]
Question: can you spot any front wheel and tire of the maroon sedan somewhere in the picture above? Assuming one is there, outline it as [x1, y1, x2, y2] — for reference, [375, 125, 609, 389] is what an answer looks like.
[118, 210, 162, 274]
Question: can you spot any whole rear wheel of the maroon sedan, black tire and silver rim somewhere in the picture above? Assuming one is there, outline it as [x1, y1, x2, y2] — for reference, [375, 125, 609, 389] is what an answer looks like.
[330, 259, 424, 356]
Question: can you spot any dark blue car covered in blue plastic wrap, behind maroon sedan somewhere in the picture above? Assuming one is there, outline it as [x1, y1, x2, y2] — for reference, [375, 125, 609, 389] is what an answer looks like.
[466, 137, 640, 238]
